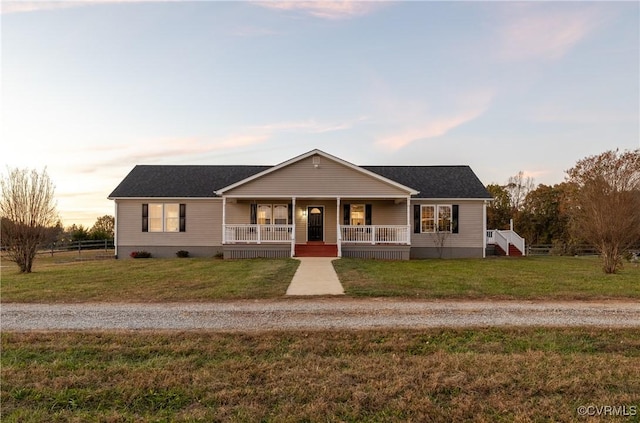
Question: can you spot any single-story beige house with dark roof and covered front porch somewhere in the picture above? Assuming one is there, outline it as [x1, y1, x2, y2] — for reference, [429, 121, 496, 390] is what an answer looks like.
[109, 150, 492, 259]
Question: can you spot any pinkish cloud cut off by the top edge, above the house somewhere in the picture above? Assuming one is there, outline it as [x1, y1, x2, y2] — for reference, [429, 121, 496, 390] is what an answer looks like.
[255, 0, 383, 20]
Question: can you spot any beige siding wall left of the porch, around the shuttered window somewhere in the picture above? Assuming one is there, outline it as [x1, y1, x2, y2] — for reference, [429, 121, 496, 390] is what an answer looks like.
[116, 199, 222, 248]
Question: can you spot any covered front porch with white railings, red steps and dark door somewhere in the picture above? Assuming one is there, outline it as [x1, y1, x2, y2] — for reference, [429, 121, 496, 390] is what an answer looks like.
[222, 197, 412, 260]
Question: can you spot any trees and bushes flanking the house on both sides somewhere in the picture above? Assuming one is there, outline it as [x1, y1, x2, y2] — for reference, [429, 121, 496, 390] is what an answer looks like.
[0, 149, 640, 273]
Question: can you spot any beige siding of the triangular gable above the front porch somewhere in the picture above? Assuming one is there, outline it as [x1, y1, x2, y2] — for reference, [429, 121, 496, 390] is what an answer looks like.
[225, 156, 408, 197]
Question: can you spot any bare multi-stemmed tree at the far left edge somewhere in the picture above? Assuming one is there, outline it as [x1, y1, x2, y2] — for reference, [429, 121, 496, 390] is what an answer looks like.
[0, 169, 58, 273]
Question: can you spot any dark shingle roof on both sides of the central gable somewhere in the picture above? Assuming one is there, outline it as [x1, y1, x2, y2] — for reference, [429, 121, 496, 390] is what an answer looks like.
[109, 165, 491, 199]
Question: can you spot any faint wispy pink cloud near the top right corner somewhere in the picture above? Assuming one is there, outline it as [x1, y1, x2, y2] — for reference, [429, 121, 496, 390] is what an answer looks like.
[498, 3, 607, 61]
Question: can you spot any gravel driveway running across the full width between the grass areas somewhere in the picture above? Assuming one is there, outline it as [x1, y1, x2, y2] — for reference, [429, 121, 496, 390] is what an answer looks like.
[0, 298, 640, 331]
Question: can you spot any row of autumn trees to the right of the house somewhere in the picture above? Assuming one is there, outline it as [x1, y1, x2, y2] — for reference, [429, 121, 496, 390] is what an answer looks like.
[487, 149, 640, 273]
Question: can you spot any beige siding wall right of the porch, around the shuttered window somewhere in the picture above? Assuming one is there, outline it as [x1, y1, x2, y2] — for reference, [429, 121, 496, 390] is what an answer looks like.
[411, 199, 484, 248]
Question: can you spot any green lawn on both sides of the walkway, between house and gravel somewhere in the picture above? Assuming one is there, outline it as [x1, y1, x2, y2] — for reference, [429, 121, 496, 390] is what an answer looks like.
[0, 256, 640, 302]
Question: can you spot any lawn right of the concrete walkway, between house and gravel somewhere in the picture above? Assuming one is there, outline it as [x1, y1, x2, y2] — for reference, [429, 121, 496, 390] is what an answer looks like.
[334, 257, 640, 300]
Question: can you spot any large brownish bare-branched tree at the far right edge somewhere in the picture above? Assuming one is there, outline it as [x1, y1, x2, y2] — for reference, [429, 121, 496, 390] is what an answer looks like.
[567, 149, 640, 273]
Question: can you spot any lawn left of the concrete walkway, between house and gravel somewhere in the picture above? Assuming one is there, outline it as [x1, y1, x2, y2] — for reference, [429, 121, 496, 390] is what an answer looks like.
[1, 257, 299, 303]
